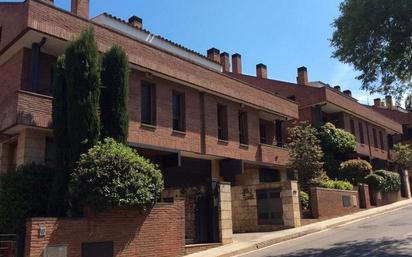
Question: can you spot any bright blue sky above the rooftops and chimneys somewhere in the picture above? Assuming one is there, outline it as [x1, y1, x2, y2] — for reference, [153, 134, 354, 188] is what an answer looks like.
[11, 0, 384, 104]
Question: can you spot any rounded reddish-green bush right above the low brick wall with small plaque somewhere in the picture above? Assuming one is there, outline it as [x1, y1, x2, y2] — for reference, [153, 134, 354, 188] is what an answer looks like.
[339, 159, 372, 185]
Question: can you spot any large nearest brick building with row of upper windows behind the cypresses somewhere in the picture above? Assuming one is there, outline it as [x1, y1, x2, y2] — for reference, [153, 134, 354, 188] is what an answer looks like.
[0, 0, 300, 252]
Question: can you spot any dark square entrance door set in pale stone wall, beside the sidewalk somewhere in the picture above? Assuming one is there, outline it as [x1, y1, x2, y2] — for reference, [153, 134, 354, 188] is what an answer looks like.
[256, 189, 283, 225]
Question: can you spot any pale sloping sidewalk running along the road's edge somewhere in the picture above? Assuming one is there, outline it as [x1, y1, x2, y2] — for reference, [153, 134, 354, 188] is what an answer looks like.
[186, 199, 412, 257]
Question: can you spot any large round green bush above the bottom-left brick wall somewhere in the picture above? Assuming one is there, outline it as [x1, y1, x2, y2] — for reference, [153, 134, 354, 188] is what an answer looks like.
[69, 138, 163, 211]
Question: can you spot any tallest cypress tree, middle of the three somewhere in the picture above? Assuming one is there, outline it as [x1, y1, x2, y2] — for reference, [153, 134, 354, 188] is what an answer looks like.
[65, 27, 100, 164]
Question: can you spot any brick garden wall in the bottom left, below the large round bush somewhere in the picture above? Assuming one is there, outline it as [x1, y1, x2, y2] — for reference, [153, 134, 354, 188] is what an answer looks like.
[25, 200, 184, 257]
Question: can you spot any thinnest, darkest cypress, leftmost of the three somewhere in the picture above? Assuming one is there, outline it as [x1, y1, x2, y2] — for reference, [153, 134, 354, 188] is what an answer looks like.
[48, 55, 70, 216]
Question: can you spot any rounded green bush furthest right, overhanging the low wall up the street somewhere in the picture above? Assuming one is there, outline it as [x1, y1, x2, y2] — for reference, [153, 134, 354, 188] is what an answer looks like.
[366, 170, 401, 193]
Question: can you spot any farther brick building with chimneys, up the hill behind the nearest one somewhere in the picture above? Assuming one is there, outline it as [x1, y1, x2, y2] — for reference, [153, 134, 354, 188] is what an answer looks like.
[227, 62, 402, 169]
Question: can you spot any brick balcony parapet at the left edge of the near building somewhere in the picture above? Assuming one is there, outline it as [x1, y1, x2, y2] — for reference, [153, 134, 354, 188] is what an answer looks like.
[0, 90, 52, 133]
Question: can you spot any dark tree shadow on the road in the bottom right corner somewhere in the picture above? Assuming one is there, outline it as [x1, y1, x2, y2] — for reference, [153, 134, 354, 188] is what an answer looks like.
[269, 237, 412, 257]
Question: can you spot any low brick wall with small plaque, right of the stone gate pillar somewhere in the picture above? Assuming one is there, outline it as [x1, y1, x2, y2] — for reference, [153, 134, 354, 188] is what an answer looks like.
[310, 187, 359, 219]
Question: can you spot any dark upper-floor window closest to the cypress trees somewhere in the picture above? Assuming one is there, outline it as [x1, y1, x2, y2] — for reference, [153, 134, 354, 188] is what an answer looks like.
[141, 81, 156, 125]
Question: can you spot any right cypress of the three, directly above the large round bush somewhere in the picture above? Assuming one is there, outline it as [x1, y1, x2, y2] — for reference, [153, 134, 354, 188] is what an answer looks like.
[100, 45, 129, 143]
